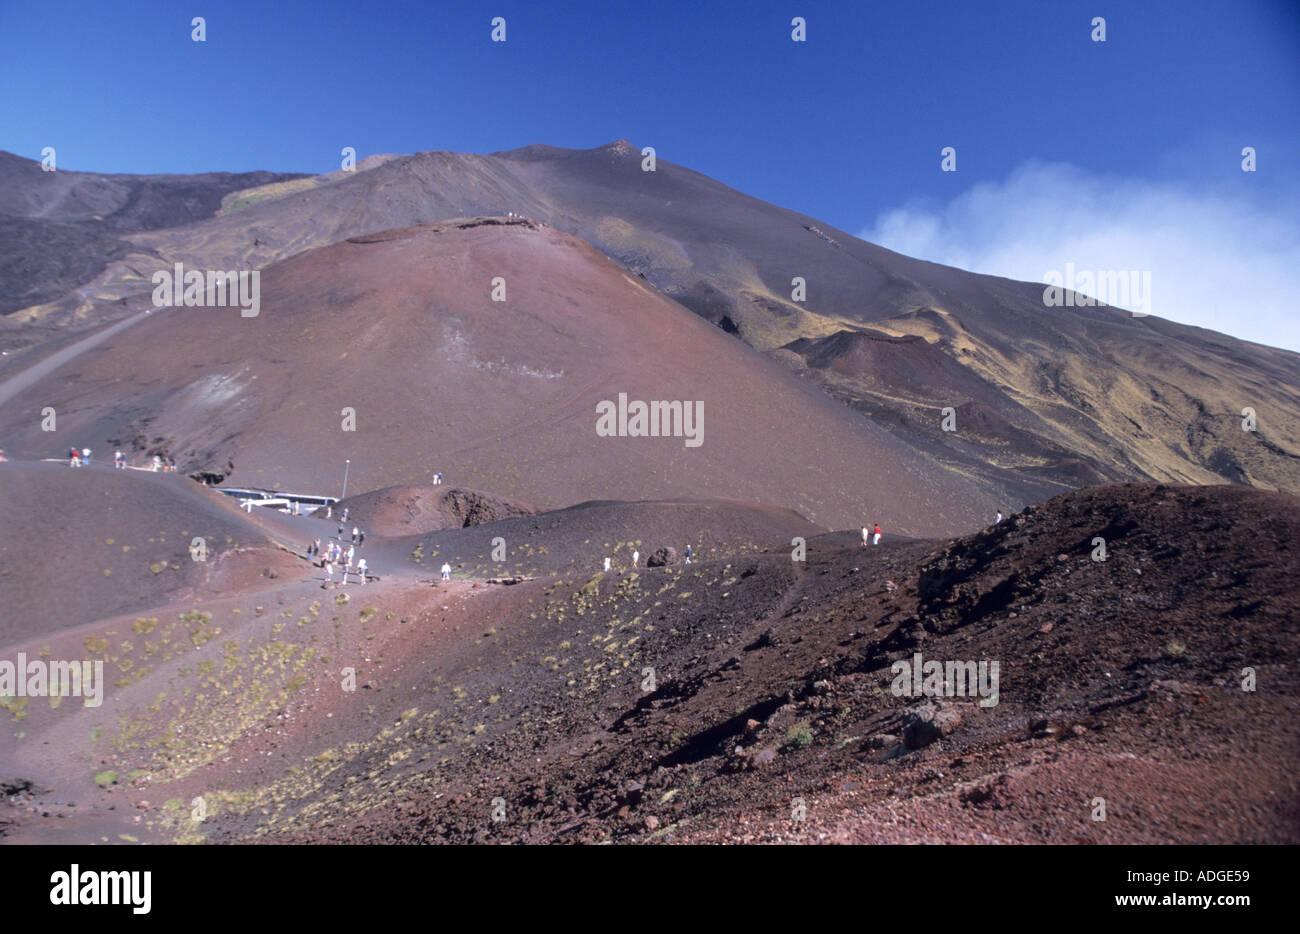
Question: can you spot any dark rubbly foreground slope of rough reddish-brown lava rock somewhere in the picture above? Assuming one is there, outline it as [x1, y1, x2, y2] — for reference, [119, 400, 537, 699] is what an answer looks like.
[250, 485, 1300, 843]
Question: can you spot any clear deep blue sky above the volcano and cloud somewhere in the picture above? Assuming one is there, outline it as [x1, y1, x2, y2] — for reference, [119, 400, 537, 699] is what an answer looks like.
[0, 0, 1300, 233]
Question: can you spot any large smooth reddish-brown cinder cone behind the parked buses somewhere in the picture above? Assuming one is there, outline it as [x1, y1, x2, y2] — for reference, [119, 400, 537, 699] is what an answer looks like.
[0, 219, 1040, 535]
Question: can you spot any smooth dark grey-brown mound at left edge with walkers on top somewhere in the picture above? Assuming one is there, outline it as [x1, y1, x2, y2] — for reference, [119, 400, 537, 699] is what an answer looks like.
[0, 462, 291, 645]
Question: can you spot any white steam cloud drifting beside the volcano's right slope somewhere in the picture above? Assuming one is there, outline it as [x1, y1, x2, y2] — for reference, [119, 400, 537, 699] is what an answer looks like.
[859, 163, 1300, 351]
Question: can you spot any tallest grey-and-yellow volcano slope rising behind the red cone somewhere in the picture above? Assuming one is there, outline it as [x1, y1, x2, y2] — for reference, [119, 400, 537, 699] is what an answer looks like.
[9, 140, 1300, 490]
